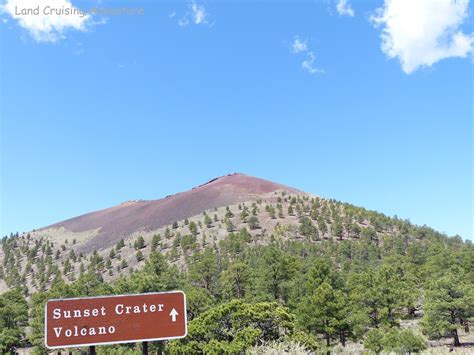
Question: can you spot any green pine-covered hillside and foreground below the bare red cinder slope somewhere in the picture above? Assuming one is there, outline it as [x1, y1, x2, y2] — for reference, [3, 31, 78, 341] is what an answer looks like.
[0, 190, 474, 353]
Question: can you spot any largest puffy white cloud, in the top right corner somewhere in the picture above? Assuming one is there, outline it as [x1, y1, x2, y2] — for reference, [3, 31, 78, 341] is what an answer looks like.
[371, 0, 474, 74]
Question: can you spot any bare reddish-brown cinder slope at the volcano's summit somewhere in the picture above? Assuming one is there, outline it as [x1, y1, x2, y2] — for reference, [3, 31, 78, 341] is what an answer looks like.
[45, 174, 299, 249]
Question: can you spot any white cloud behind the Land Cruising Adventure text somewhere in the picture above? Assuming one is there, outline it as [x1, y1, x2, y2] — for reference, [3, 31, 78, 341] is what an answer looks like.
[0, 0, 91, 42]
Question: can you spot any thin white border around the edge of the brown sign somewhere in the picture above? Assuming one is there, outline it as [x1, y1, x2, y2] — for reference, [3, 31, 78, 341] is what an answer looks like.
[44, 290, 188, 349]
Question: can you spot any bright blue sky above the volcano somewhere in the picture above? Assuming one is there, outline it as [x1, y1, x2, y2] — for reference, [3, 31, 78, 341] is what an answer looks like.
[0, 0, 474, 239]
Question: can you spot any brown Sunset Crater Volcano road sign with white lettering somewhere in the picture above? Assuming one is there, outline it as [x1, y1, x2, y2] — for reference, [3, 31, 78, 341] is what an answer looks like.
[44, 291, 187, 348]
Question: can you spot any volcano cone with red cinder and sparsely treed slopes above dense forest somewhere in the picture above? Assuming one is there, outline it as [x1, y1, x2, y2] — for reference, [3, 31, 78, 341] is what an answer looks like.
[0, 174, 460, 292]
